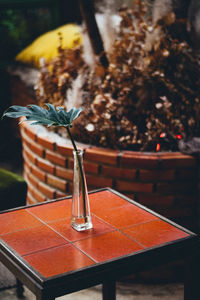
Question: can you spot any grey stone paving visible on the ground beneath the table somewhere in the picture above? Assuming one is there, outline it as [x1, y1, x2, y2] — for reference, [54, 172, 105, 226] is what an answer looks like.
[0, 283, 184, 300]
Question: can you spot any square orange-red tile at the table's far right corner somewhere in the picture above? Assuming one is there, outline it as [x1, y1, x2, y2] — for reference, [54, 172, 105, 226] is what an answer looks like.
[123, 220, 188, 247]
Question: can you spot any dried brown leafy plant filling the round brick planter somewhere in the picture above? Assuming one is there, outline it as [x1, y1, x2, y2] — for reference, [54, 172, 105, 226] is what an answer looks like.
[36, 1, 200, 151]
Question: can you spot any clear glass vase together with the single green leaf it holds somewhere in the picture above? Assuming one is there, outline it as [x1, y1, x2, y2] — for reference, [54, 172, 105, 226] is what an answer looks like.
[3, 103, 92, 231]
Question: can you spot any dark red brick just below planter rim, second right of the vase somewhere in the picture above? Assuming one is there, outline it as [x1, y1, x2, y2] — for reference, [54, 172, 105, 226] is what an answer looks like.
[101, 165, 137, 179]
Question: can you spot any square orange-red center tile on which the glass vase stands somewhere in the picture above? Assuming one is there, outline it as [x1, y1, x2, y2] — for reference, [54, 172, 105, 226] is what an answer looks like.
[49, 216, 115, 242]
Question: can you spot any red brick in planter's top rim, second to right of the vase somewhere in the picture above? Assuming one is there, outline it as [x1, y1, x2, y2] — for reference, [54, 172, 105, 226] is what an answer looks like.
[120, 151, 159, 169]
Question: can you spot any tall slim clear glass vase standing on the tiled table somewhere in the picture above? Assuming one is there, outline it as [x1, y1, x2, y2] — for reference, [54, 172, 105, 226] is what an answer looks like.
[71, 150, 92, 231]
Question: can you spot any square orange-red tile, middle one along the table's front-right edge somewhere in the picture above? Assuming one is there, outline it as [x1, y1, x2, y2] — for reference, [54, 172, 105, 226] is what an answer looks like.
[74, 231, 144, 262]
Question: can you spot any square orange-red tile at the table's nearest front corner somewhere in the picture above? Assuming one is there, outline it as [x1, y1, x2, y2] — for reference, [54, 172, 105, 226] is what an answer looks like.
[24, 244, 94, 277]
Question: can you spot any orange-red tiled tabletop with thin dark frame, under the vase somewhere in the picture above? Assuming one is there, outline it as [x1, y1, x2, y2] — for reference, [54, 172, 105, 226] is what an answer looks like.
[0, 189, 195, 298]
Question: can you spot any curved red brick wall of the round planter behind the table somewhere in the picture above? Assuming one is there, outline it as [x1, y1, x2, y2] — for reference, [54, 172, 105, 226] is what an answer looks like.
[21, 123, 198, 231]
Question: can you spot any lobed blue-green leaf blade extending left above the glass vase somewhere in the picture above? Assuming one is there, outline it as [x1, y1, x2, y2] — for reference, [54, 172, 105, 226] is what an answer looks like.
[2, 103, 82, 127]
